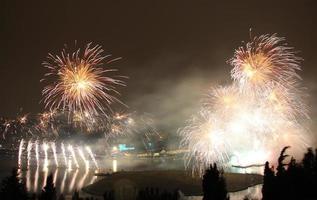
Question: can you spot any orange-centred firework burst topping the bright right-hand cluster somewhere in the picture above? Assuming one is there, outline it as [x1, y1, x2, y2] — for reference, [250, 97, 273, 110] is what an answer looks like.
[230, 34, 301, 91]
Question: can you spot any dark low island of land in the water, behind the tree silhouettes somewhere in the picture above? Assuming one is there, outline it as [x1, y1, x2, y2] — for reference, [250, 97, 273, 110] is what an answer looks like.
[83, 170, 263, 199]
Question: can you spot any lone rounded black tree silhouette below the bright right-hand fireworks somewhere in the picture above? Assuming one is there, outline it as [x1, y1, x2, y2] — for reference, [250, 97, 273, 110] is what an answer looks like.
[202, 164, 229, 200]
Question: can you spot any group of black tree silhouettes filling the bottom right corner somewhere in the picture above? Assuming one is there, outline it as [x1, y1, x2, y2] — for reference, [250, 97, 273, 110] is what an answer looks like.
[262, 147, 317, 200]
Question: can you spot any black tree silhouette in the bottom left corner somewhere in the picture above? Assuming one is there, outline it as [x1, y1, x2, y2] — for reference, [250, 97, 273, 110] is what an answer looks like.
[0, 168, 28, 200]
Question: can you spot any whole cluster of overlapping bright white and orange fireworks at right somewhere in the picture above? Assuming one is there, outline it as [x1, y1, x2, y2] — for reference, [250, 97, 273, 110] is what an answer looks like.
[179, 35, 309, 175]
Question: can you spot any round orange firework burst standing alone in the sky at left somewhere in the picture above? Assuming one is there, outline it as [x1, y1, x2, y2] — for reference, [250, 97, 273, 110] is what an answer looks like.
[42, 44, 125, 117]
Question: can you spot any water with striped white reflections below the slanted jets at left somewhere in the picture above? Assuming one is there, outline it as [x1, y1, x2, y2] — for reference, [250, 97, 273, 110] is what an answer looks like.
[9, 154, 183, 194]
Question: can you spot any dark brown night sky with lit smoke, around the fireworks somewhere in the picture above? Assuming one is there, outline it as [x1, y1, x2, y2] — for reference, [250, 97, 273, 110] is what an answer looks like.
[0, 0, 317, 134]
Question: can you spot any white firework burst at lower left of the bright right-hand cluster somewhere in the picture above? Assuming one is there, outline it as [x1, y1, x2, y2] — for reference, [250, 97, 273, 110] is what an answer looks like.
[180, 110, 231, 174]
